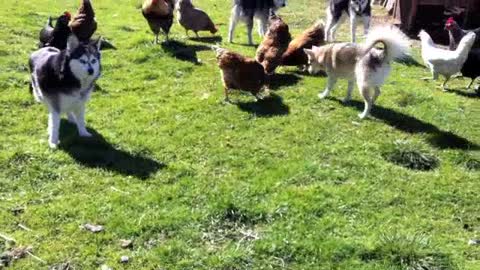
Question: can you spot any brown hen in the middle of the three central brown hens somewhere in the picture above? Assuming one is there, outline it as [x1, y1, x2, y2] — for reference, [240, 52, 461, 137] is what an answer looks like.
[256, 14, 292, 74]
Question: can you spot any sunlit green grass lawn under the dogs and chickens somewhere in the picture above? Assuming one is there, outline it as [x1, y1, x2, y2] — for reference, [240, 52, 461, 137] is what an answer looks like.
[0, 0, 480, 269]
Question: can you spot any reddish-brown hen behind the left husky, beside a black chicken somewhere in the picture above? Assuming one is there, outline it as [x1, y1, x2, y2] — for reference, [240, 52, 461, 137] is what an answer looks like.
[69, 0, 97, 42]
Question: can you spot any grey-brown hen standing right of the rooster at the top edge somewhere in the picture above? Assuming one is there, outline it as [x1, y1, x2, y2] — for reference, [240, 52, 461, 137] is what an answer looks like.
[177, 0, 218, 37]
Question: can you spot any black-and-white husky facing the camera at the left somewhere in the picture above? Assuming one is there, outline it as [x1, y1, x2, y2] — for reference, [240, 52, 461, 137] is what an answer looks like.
[29, 35, 101, 148]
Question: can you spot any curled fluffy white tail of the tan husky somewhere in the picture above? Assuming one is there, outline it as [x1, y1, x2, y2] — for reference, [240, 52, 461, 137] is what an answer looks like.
[364, 25, 410, 62]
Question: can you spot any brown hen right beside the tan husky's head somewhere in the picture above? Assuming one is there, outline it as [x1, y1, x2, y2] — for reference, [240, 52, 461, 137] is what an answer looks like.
[282, 21, 325, 66]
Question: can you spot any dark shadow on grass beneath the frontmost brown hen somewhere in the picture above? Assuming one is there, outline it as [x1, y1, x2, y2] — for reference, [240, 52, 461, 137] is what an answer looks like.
[236, 94, 290, 117]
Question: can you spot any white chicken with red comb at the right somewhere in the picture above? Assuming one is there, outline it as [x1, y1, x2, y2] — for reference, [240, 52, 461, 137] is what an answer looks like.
[418, 30, 475, 90]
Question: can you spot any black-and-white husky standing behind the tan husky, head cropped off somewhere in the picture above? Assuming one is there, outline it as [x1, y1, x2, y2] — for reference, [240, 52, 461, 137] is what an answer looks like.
[325, 0, 372, 42]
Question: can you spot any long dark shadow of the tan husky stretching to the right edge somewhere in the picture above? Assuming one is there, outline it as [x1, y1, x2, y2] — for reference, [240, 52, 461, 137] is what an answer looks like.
[330, 98, 480, 150]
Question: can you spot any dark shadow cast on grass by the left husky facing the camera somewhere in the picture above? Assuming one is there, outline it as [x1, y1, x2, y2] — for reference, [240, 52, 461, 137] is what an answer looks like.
[60, 120, 167, 179]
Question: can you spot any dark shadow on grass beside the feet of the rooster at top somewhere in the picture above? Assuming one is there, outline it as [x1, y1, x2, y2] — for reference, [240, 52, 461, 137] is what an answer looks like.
[161, 40, 211, 65]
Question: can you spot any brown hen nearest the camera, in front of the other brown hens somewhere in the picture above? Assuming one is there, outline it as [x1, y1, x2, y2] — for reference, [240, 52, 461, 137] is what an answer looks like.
[213, 46, 268, 102]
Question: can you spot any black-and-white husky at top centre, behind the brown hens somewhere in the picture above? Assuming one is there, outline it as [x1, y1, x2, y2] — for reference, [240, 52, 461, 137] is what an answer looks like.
[228, 0, 287, 45]
